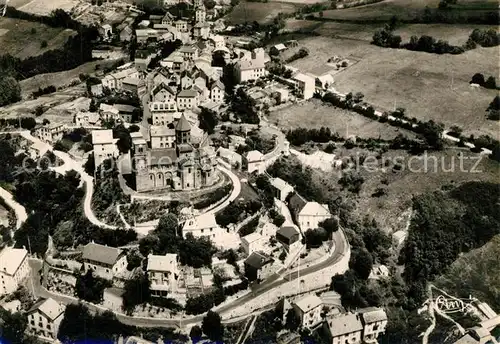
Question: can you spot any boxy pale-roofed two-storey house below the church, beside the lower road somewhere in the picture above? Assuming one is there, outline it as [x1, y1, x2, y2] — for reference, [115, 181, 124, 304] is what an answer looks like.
[147, 253, 179, 297]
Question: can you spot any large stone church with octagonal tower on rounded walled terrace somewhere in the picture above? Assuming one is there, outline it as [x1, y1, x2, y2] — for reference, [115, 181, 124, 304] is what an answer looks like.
[132, 114, 218, 192]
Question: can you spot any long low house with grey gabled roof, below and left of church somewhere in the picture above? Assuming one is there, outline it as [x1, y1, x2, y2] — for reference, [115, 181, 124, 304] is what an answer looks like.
[82, 242, 127, 280]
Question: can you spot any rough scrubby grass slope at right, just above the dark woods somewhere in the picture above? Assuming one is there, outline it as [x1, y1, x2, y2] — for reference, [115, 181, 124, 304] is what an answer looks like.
[304, 148, 500, 233]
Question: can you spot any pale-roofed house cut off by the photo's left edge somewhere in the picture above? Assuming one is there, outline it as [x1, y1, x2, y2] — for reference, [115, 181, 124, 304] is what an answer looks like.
[0, 247, 30, 296]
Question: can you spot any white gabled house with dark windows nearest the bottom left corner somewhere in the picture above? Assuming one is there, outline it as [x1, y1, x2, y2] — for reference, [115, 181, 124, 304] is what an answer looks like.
[26, 298, 65, 342]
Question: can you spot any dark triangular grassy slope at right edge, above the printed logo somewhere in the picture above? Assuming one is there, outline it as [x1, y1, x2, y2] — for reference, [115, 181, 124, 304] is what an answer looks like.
[435, 235, 500, 311]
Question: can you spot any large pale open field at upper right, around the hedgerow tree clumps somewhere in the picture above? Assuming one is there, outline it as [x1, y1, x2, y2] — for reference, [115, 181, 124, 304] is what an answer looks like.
[274, 29, 500, 137]
